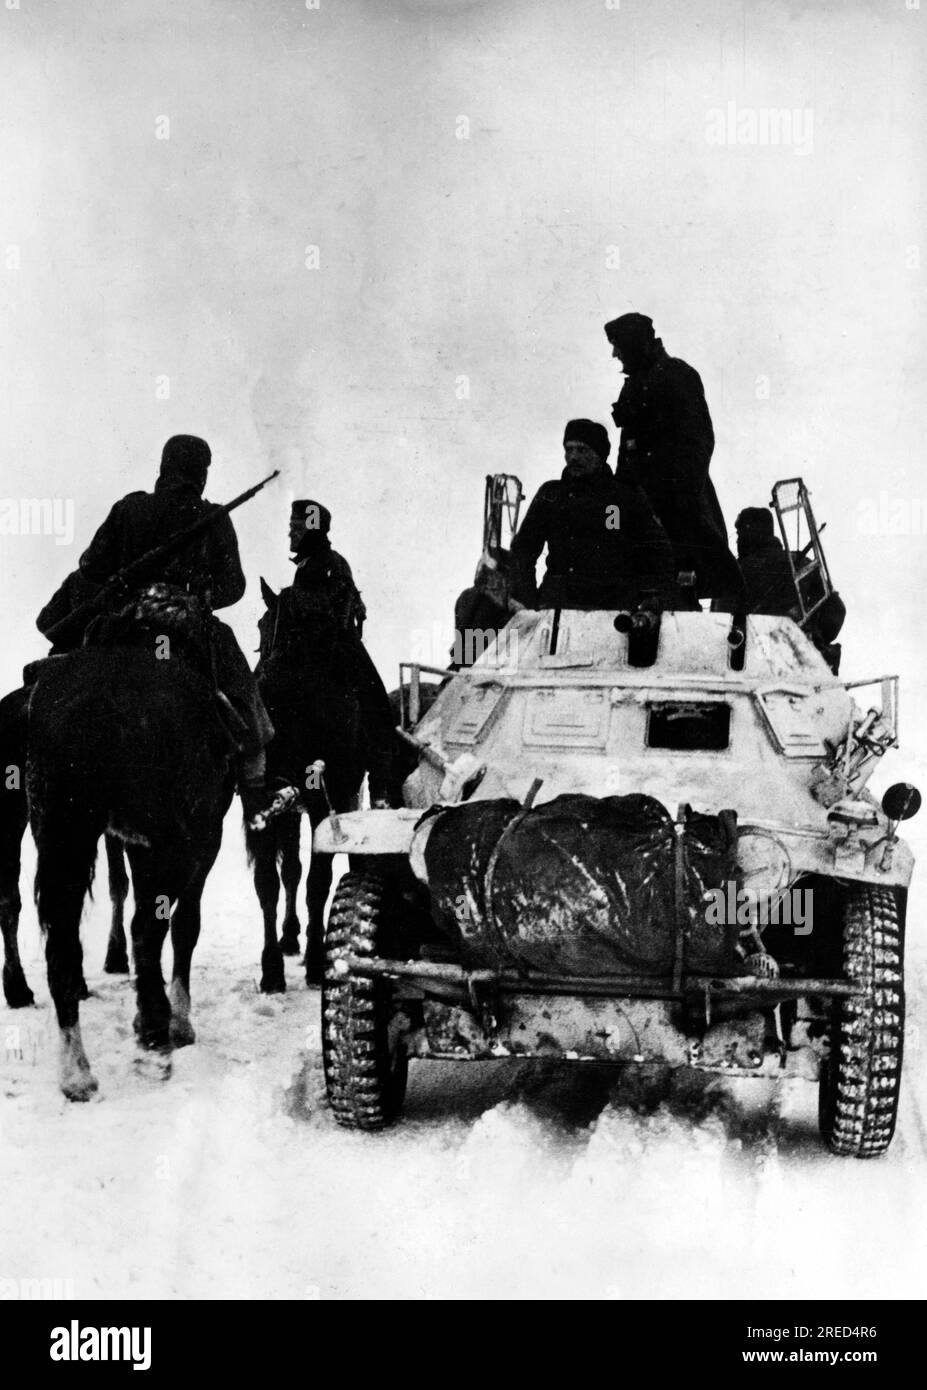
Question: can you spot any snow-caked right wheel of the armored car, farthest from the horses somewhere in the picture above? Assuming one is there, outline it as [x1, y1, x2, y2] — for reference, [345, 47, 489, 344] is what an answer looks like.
[819, 884, 905, 1158]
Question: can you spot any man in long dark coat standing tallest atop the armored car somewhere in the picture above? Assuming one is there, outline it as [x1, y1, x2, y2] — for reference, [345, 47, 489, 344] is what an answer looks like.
[605, 314, 744, 607]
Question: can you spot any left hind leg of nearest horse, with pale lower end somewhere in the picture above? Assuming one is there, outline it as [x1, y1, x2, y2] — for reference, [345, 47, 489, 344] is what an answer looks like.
[36, 823, 99, 1101]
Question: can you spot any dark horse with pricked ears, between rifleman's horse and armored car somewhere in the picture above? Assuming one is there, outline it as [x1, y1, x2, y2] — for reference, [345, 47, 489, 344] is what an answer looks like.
[245, 578, 396, 994]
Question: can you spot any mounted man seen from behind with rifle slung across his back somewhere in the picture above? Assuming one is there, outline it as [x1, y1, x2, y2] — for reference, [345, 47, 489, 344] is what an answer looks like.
[36, 435, 274, 817]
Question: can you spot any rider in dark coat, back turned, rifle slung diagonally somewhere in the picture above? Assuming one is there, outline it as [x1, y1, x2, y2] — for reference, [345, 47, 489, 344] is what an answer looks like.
[36, 435, 274, 813]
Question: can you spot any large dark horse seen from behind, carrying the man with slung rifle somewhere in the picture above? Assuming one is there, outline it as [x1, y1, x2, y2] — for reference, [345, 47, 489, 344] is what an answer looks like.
[26, 641, 233, 1101]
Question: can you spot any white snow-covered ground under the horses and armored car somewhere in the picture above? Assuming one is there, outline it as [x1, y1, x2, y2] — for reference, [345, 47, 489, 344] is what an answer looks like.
[0, 812, 927, 1298]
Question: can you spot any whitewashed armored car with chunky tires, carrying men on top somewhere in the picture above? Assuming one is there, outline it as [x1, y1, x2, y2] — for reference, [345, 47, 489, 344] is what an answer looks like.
[314, 480, 920, 1158]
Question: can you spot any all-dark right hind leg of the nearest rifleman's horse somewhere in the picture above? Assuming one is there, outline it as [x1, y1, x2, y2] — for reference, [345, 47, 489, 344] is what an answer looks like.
[128, 845, 178, 1052]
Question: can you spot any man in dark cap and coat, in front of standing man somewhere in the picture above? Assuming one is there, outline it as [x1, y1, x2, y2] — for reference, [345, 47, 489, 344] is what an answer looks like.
[511, 420, 673, 610]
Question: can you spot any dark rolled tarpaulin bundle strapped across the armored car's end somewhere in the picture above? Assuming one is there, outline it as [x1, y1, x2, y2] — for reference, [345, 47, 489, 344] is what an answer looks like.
[424, 795, 738, 977]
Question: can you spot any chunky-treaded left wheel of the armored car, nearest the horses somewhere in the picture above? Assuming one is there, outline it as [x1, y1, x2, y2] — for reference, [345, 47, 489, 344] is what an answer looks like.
[322, 869, 409, 1130]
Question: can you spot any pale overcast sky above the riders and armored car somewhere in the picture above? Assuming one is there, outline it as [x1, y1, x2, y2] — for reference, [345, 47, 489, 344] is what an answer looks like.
[0, 0, 927, 800]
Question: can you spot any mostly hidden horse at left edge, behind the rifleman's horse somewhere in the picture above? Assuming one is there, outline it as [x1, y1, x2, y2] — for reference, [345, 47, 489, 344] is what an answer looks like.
[0, 675, 129, 1009]
